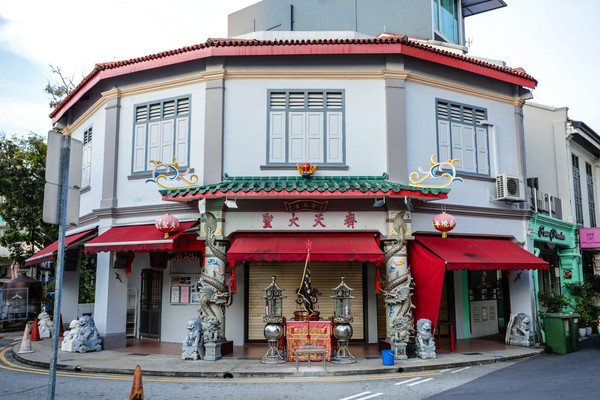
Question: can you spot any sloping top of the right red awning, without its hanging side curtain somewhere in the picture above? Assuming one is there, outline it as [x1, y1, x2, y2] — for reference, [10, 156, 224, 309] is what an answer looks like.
[417, 236, 548, 270]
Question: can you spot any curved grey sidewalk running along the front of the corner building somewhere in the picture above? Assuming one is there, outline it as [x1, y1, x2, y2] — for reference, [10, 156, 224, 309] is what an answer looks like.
[5, 336, 544, 378]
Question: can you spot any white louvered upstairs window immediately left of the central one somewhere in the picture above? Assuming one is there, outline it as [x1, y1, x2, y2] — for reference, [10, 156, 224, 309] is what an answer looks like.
[132, 97, 190, 173]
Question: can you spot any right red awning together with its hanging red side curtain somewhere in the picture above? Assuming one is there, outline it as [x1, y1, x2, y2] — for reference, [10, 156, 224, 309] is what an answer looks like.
[408, 236, 548, 327]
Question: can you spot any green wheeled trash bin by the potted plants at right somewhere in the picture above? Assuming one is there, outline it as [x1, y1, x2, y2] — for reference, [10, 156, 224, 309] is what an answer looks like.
[540, 313, 579, 354]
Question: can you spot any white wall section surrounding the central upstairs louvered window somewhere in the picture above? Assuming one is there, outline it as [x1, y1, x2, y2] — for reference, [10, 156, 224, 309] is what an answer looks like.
[224, 79, 386, 176]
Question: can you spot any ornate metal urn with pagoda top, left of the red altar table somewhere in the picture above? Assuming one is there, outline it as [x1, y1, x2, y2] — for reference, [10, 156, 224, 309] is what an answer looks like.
[260, 276, 285, 364]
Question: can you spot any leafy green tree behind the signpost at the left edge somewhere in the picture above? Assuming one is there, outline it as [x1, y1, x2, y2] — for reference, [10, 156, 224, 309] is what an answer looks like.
[0, 133, 58, 262]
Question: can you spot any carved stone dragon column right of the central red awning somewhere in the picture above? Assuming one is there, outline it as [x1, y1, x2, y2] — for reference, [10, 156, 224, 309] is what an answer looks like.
[382, 212, 414, 358]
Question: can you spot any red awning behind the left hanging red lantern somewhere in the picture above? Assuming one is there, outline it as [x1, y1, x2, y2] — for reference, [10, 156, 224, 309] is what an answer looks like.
[85, 221, 197, 253]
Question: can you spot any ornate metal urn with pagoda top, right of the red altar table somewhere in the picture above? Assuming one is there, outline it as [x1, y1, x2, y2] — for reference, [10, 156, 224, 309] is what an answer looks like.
[331, 276, 356, 364]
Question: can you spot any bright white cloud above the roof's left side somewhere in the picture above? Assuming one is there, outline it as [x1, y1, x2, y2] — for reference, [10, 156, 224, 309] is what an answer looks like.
[0, 0, 256, 81]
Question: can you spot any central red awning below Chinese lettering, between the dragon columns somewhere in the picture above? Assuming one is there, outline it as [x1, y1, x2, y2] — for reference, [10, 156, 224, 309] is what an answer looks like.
[227, 234, 385, 262]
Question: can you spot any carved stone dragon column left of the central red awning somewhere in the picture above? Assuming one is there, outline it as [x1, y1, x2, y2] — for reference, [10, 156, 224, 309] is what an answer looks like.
[198, 211, 230, 341]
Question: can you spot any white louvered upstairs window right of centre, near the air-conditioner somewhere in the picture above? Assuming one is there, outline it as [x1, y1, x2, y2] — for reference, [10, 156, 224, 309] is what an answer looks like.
[436, 100, 490, 176]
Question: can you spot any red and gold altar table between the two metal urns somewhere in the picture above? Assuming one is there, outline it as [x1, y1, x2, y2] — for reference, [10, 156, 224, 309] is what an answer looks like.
[285, 321, 331, 361]
